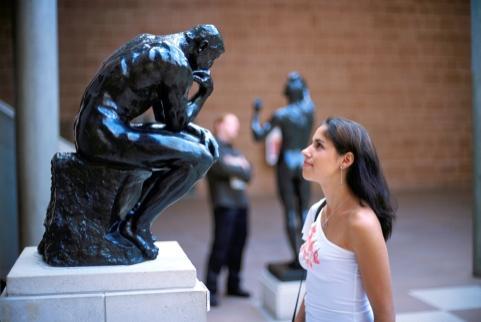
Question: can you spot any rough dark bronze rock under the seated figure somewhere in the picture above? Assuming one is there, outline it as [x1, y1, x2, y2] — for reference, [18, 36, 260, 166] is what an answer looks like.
[38, 153, 152, 266]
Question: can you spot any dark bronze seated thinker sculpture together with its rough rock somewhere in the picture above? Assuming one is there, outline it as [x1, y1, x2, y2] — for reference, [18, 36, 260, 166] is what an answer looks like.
[38, 25, 224, 266]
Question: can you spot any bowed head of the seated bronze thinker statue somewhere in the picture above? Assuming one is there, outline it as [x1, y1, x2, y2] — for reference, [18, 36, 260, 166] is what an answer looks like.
[184, 25, 224, 70]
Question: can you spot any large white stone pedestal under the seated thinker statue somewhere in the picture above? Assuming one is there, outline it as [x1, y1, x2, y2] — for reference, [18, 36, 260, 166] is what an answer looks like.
[0, 242, 209, 322]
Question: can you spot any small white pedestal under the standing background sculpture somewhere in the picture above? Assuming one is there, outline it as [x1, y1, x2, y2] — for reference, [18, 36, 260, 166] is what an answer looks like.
[261, 270, 305, 321]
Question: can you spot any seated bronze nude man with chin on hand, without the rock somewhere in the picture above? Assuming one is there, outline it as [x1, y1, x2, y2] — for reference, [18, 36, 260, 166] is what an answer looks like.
[39, 25, 224, 259]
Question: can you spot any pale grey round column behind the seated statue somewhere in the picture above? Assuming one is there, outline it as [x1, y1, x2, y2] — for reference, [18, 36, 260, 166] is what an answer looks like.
[15, 0, 59, 248]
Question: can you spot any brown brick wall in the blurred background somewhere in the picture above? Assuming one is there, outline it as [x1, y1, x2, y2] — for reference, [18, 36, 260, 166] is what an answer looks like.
[0, 0, 472, 195]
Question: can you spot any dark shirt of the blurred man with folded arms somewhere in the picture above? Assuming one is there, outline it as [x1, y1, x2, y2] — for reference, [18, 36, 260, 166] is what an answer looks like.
[207, 138, 252, 208]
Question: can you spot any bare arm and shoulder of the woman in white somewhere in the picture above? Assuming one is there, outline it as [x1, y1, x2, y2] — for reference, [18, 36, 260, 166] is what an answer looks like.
[349, 208, 395, 322]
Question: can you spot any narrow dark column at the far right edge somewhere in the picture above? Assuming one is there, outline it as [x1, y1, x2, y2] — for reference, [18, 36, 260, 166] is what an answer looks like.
[471, 0, 481, 276]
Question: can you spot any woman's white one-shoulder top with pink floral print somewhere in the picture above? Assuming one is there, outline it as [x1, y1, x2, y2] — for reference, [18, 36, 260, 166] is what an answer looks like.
[299, 199, 374, 322]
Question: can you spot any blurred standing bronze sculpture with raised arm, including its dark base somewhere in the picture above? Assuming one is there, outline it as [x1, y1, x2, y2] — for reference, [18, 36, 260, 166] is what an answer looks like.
[251, 72, 314, 280]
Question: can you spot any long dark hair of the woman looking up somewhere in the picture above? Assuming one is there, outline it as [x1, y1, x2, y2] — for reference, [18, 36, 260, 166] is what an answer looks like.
[323, 117, 396, 240]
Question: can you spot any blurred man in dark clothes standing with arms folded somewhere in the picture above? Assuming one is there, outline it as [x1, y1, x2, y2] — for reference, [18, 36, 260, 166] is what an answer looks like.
[206, 114, 252, 306]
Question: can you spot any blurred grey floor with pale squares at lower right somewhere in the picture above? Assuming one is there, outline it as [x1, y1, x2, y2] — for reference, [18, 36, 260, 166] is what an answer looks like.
[153, 191, 481, 322]
